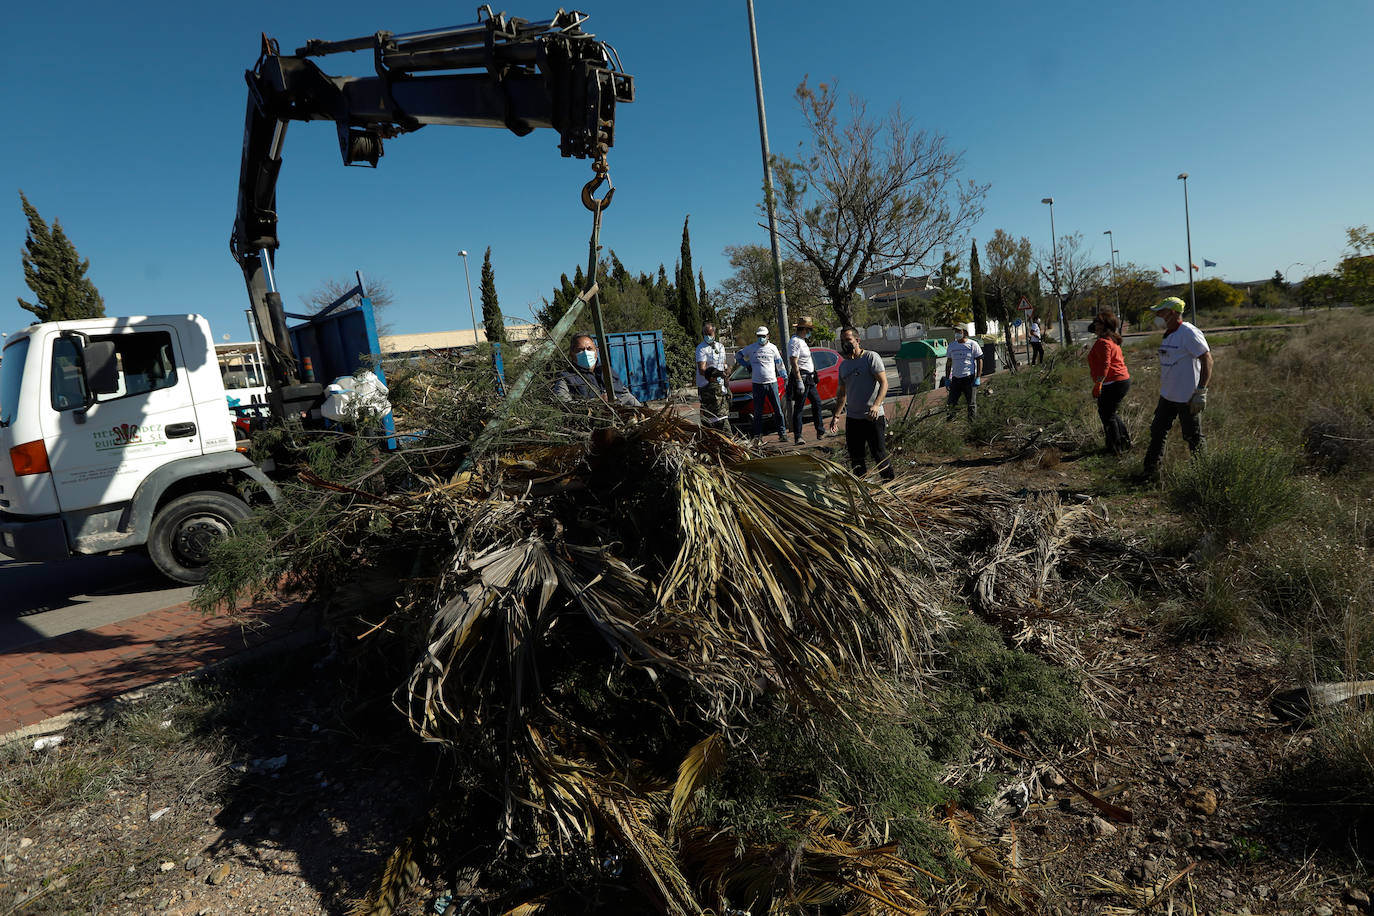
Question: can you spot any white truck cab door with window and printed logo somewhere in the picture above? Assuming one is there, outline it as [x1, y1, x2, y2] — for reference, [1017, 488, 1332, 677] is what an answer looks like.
[43, 325, 202, 512]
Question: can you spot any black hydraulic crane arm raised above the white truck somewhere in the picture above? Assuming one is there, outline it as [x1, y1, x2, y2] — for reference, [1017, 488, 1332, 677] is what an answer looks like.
[229, 5, 635, 416]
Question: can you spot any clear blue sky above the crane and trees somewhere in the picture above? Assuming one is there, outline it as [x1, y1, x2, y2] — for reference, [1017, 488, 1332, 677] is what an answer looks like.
[0, 0, 1374, 339]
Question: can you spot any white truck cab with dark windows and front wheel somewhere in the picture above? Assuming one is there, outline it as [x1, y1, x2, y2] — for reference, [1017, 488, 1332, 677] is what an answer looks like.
[0, 314, 278, 582]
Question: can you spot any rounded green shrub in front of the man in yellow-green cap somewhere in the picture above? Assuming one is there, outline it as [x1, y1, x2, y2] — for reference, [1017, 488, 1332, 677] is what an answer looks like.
[1169, 444, 1301, 542]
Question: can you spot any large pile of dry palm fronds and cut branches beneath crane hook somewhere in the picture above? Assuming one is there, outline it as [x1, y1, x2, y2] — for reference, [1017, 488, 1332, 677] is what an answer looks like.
[202, 357, 1126, 915]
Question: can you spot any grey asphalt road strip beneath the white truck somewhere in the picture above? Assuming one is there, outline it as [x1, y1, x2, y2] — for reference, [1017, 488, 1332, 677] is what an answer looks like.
[0, 552, 194, 651]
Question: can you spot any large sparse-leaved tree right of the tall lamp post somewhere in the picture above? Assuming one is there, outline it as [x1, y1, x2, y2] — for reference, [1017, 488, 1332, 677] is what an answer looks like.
[774, 80, 988, 324]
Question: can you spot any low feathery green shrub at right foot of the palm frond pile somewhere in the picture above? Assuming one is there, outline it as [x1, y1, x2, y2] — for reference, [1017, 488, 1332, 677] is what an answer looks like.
[701, 615, 1092, 871]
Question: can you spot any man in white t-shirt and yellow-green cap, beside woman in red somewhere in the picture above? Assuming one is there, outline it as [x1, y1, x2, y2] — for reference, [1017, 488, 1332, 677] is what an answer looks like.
[1145, 295, 1212, 478]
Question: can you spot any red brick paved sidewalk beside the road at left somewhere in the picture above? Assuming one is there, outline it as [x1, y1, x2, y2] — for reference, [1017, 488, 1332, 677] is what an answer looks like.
[0, 602, 313, 737]
